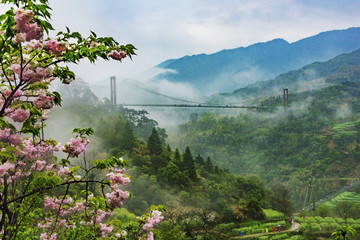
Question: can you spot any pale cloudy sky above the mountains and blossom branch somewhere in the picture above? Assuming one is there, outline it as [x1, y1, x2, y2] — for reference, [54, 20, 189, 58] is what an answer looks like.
[2, 0, 360, 83]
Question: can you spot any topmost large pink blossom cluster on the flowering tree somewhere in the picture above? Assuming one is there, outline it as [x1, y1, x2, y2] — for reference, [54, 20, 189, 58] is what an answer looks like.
[14, 8, 43, 43]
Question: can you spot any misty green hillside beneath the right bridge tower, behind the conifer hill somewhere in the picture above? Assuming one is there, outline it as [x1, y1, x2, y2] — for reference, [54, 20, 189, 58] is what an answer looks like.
[174, 74, 360, 212]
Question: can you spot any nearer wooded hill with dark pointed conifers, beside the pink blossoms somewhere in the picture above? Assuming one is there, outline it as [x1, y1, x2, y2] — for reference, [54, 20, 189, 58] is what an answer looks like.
[49, 85, 293, 239]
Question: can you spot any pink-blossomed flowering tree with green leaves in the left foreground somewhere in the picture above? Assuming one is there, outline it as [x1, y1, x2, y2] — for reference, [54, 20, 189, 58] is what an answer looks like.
[0, 0, 164, 239]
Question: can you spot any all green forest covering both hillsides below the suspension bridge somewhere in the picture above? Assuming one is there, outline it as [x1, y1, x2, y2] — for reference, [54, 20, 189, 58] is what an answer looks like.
[49, 74, 360, 239]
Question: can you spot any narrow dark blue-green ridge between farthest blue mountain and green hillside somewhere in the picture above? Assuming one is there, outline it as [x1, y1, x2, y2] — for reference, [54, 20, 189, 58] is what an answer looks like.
[208, 49, 360, 103]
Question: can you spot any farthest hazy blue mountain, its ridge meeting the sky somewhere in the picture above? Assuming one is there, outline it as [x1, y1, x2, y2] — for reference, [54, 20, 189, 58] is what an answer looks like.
[156, 27, 360, 95]
